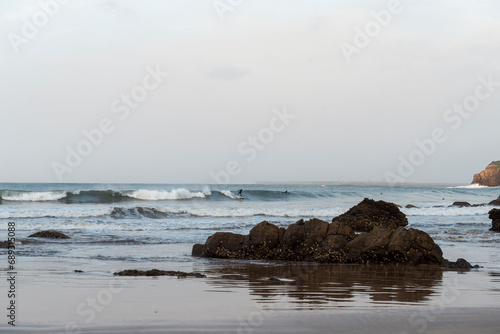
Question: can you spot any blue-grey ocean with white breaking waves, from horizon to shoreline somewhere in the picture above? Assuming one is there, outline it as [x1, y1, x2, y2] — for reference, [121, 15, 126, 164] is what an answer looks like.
[0, 183, 500, 271]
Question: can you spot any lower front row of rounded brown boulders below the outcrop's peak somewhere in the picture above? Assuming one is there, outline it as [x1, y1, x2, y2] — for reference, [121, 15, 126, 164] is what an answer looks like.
[193, 219, 443, 264]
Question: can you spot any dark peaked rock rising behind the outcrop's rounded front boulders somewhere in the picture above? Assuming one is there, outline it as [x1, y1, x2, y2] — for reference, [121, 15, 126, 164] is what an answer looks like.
[333, 198, 408, 232]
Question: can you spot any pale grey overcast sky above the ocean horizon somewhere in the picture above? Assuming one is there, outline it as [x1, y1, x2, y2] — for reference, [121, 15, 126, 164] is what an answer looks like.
[0, 0, 500, 183]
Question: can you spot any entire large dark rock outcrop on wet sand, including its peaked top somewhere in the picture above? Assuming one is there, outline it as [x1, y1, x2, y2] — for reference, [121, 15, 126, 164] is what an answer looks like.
[193, 199, 468, 269]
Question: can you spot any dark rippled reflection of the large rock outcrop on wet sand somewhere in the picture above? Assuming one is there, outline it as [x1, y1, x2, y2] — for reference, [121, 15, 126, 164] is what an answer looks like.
[203, 262, 443, 309]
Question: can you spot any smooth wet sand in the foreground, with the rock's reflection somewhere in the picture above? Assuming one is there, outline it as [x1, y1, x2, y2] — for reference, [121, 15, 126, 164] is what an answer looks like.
[0, 258, 500, 333]
